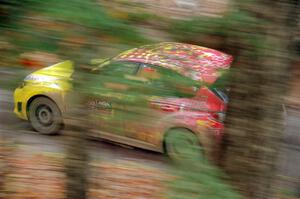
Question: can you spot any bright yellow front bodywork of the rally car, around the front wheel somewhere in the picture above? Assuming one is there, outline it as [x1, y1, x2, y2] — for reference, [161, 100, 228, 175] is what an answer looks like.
[14, 61, 74, 120]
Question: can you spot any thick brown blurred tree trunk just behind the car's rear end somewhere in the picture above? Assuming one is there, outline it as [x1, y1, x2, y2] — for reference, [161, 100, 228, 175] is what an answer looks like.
[221, 1, 295, 199]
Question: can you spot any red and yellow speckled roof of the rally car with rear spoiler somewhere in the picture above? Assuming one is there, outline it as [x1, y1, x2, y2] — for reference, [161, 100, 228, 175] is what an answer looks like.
[114, 42, 232, 83]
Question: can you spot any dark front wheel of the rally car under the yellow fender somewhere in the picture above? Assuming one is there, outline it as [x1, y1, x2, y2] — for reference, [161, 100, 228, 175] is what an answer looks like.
[28, 97, 63, 135]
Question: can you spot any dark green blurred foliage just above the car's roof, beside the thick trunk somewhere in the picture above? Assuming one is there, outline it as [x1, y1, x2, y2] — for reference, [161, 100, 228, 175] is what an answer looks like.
[168, 10, 267, 54]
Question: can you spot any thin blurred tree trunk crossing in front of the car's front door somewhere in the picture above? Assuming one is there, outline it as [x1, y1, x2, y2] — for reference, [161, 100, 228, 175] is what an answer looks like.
[65, 47, 92, 199]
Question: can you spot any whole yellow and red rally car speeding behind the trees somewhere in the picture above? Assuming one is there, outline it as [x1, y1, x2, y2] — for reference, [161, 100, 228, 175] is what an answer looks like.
[14, 42, 232, 158]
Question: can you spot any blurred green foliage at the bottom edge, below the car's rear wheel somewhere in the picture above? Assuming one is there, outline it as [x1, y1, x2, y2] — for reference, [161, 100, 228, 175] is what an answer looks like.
[167, 161, 241, 199]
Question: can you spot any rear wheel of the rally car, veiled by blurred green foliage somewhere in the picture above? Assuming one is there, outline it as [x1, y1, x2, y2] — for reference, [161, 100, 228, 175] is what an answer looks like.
[165, 129, 204, 161]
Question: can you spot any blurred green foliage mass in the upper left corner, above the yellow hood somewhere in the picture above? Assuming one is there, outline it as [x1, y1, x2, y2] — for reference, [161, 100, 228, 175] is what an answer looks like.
[0, 0, 149, 56]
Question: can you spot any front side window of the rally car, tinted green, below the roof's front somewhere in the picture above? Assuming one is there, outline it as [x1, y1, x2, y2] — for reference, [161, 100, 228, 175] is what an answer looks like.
[100, 61, 139, 77]
